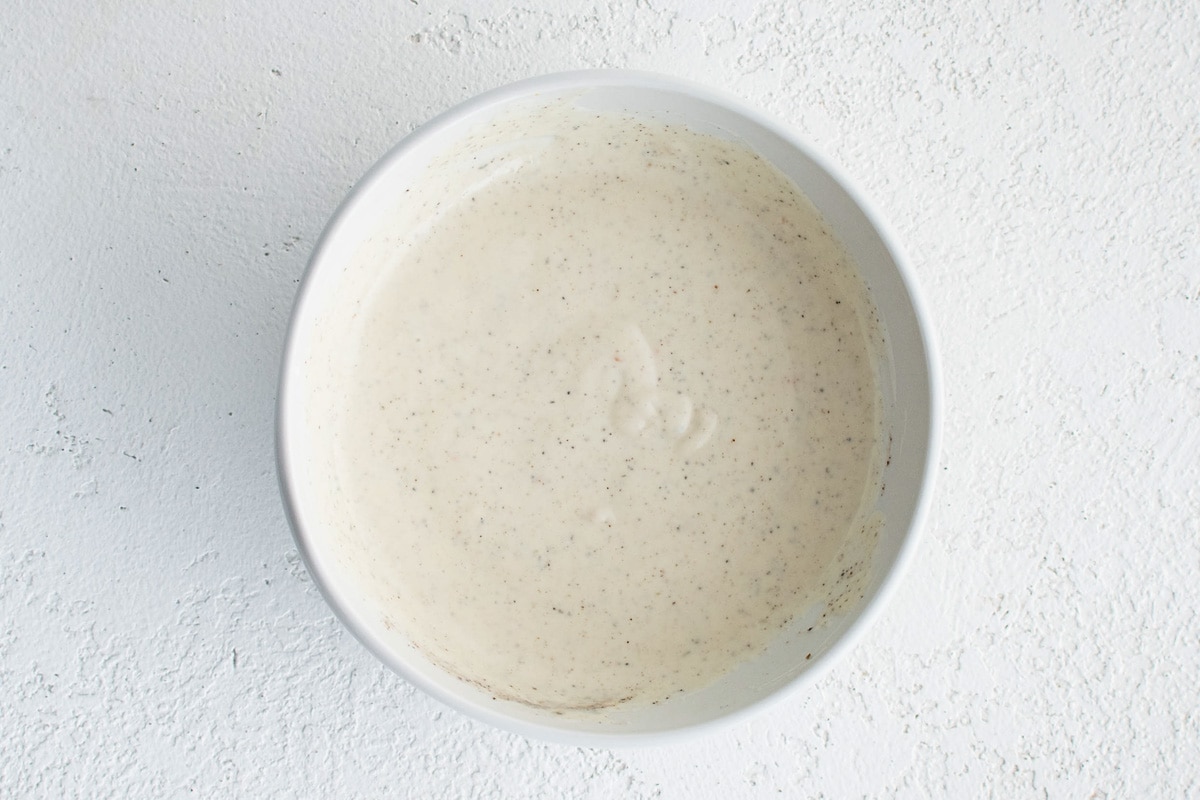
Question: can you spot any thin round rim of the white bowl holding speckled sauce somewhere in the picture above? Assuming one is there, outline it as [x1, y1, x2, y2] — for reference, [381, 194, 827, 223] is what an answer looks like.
[275, 70, 942, 747]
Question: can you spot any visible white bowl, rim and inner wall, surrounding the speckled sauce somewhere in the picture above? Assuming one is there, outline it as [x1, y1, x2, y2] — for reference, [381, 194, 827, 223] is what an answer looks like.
[277, 71, 940, 746]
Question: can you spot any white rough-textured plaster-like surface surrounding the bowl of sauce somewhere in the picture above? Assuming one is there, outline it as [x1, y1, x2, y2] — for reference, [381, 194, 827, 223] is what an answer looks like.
[0, 0, 1200, 799]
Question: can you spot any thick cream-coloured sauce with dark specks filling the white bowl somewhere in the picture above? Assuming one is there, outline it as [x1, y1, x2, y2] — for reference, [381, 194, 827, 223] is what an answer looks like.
[304, 104, 881, 709]
